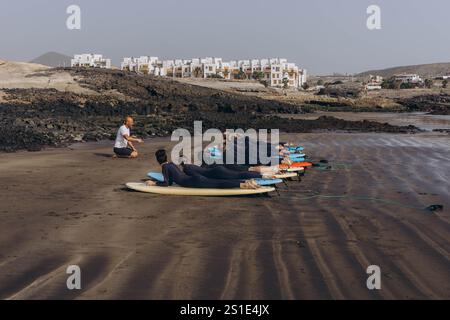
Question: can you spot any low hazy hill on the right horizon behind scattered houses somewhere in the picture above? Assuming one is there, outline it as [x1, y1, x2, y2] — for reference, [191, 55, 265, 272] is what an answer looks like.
[358, 63, 450, 78]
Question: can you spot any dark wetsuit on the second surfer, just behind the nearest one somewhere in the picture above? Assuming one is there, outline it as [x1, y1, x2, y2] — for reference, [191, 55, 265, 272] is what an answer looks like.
[183, 164, 262, 180]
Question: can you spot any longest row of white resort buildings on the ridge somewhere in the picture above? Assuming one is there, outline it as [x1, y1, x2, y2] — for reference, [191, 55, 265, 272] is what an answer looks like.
[121, 56, 306, 88]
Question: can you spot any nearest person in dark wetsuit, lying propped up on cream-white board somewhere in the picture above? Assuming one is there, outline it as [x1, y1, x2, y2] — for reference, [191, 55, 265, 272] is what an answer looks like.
[147, 150, 259, 189]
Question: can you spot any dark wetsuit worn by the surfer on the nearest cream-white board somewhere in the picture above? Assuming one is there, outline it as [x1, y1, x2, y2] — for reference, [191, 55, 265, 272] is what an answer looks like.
[156, 162, 242, 189]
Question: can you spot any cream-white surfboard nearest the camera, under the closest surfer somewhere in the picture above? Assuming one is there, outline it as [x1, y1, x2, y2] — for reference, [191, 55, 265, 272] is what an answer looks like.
[126, 182, 275, 197]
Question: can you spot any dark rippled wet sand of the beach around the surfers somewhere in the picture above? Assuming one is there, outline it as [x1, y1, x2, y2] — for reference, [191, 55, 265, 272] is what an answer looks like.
[0, 133, 450, 299]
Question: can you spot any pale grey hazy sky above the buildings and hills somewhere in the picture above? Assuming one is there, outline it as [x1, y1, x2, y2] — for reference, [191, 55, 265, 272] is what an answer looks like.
[0, 0, 450, 74]
